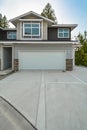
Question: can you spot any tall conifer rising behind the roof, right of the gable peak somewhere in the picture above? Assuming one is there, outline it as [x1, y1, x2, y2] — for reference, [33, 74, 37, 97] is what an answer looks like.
[41, 3, 57, 24]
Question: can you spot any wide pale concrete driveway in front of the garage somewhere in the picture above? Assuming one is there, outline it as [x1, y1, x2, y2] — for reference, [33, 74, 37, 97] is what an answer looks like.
[0, 67, 87, 130]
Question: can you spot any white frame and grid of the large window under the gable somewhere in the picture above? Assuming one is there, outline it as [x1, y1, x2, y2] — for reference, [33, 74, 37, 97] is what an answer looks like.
[23, 21, 41, 38]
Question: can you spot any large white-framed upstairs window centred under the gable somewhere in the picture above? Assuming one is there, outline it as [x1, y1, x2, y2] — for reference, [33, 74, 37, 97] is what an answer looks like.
[23, 22, 40, 38]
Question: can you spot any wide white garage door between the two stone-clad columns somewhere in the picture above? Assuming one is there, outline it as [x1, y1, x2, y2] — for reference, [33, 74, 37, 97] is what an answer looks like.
[19, 52, 65, 70]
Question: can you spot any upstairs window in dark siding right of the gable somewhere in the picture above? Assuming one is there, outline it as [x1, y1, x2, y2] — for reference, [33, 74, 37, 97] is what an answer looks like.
[58, 28, 69, 38]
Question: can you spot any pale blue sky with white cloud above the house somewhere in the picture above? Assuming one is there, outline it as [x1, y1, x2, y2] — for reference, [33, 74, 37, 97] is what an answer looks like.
[0, 0, 87, 36]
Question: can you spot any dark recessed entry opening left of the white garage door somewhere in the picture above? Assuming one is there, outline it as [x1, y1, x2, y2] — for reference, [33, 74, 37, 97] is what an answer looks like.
[3, 47, 12, 70]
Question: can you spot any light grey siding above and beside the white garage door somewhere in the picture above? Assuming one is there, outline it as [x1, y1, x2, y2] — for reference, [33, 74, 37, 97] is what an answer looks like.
[14, 44, 72, 59]
